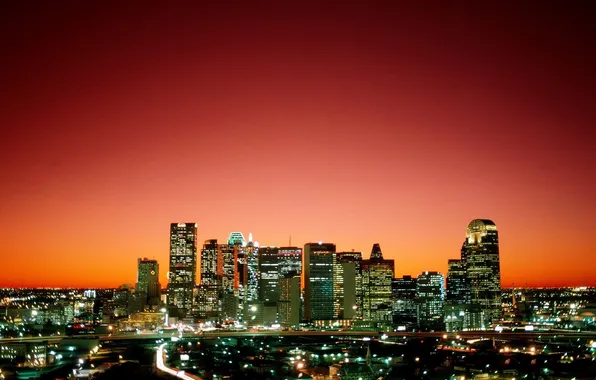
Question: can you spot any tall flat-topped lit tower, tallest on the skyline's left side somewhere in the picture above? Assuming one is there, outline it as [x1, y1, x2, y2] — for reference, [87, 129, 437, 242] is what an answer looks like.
[168, 223, 197, 316]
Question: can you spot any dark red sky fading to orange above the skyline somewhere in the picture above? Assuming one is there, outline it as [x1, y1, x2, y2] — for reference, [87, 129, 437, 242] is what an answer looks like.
[0, 1, 596, 286]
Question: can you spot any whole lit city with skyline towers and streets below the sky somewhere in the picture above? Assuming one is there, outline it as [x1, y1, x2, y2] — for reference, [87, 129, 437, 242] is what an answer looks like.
[0, 219, 596, 379]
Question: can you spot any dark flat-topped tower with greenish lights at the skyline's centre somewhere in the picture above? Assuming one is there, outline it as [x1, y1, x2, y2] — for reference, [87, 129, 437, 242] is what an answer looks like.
[303, 242, 335, 320]
